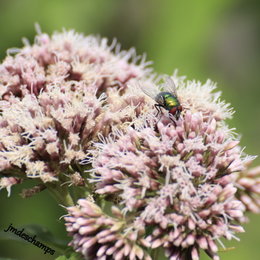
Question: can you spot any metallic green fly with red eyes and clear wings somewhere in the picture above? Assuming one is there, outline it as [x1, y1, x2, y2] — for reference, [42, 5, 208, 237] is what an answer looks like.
[140, 77, 182, 120]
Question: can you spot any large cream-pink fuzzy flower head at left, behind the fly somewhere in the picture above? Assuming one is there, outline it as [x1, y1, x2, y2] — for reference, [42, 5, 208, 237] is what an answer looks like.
[0, 31, 151, 193]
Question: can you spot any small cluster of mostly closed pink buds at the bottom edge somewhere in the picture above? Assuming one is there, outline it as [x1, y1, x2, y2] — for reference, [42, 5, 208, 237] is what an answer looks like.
[64, 199, 152, 260]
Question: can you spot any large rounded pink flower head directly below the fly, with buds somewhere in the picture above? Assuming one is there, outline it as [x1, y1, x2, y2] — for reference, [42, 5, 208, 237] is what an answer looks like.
[85, 74, 254, 259]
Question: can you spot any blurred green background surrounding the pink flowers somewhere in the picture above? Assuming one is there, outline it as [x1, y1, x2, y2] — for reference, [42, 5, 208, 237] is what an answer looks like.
[0, 0, 260, 260]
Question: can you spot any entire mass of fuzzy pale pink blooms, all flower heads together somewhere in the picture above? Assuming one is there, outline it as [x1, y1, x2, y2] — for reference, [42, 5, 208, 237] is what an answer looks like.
[0, 31, 260, 260]
